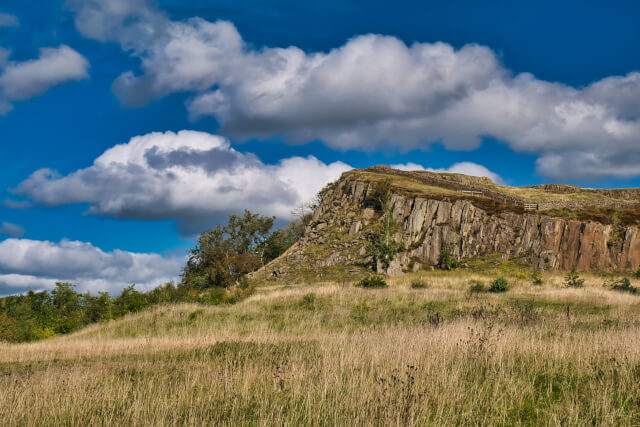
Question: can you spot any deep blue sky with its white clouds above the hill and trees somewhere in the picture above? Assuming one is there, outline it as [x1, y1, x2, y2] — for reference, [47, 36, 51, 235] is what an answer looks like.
[0, 0, 640, 294]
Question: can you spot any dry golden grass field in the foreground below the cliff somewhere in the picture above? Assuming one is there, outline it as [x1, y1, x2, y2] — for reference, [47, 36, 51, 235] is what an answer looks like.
[0, 272, 640, 426]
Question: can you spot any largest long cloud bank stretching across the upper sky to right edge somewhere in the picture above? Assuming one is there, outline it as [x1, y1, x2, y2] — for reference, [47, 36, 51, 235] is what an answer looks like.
[68, 0, 640, 178]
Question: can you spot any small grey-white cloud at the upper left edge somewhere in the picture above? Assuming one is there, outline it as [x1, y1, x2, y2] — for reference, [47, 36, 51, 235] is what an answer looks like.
[0, 45, 89, 115]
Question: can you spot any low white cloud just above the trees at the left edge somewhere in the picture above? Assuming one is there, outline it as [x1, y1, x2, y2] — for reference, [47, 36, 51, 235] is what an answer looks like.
[0, 239, 185, 295]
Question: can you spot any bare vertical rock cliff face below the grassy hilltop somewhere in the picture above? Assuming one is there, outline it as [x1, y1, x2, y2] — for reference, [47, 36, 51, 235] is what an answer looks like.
[272, 175, 640, 274]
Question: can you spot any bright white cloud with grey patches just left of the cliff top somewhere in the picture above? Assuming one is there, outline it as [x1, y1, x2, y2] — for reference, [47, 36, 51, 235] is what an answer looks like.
[15, 131, 350, 234]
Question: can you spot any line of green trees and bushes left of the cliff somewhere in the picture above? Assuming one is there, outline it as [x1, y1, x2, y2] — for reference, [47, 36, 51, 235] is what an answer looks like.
[0, 209, 311, 342]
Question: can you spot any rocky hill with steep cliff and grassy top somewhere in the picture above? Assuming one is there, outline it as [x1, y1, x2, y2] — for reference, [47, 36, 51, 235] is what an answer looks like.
[254, 166, 640, 281]
